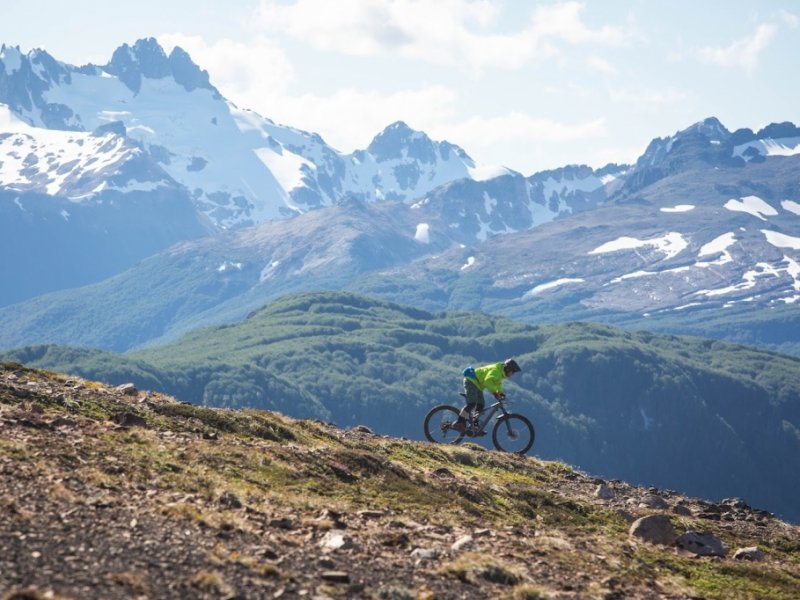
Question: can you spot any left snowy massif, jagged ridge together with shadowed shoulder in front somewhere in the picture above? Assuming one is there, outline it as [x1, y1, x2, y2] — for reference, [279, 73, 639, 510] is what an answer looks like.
[0, 39, 520, 305]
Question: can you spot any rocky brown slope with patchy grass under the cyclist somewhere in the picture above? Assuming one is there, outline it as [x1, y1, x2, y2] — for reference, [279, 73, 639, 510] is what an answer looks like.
[0, 363, 800, 600]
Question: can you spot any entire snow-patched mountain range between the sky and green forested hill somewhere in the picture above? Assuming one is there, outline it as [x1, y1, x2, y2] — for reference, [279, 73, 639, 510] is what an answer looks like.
[0, 39, 800, 351]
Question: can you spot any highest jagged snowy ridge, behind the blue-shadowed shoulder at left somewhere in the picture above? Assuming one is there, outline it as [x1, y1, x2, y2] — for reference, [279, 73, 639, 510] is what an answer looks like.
[0, 38, 506, 228]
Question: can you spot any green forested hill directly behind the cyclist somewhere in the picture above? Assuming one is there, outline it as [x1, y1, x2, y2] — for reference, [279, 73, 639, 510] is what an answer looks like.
[5, 293, 800, 520]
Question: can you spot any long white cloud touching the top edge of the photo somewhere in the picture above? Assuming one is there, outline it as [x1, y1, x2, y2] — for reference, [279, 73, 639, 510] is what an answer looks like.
[253, 0, 628, 71]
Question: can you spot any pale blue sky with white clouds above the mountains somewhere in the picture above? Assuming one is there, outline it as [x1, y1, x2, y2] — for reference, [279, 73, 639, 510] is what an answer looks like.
[0, 0, 800, 175]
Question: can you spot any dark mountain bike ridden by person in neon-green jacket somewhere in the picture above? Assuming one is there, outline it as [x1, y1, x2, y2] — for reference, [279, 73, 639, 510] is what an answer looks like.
[423, 394, 536, 454]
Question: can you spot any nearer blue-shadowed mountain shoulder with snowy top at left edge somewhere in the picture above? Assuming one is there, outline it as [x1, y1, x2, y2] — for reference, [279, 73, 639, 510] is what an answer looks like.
[0, 105, 214, 305]
